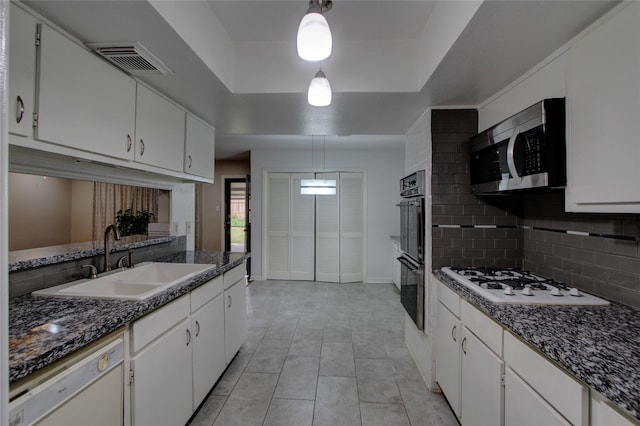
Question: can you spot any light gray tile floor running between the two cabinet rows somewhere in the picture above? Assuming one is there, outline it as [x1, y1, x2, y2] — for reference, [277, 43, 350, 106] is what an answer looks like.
[191, 281, 457, 426]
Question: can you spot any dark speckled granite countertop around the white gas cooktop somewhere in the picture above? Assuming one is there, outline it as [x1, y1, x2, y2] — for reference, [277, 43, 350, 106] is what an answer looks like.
[433, 269, 640, 419]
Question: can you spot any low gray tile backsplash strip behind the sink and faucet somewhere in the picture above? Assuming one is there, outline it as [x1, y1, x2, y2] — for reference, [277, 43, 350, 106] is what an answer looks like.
[9, 236, 187, 297]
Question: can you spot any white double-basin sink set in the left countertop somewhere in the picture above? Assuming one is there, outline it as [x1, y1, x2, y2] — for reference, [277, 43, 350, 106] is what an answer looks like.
[33, 262, 216, 300]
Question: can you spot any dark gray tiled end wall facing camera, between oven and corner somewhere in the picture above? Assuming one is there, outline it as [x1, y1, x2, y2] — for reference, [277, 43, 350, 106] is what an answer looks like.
[431, 110, 522, 268]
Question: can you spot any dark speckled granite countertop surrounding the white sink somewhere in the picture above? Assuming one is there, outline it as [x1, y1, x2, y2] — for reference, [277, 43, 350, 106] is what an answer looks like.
[9, 251, 250, 383]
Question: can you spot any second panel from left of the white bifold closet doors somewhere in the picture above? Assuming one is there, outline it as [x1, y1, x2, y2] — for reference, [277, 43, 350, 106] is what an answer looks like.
[289, 173, 315, 280]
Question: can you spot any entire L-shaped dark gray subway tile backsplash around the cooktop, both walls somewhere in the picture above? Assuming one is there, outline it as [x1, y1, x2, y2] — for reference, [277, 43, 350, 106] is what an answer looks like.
[431, 110, 640, 308]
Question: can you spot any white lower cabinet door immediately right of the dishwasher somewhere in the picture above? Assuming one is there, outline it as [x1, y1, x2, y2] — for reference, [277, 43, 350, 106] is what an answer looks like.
[131, 319, 193, 426]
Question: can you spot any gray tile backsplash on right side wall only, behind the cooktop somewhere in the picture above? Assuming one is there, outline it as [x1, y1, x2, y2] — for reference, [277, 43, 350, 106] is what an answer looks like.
[523, 191, 640, 307]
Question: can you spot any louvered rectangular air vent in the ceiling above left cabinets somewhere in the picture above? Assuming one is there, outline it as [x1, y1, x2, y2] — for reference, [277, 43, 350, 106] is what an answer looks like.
[86, 41, 173, 75]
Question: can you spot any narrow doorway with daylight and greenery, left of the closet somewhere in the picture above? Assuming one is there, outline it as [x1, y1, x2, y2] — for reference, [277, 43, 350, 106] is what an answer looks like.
[224, 175, 251, 253]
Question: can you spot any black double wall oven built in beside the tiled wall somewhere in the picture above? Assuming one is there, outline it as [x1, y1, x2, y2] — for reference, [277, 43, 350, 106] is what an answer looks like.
[398, 170, 425, 330]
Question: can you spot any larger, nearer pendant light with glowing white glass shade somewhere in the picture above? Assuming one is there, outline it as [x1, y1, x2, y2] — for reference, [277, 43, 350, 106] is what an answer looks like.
[297, 0, 333, 61]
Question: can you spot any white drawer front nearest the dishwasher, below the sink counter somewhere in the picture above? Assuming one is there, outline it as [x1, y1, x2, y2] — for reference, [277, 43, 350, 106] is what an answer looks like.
[131, 295, 190, 353]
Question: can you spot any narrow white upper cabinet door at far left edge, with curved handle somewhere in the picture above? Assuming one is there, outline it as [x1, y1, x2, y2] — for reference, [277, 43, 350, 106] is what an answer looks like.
[9, 3, 37, 136]
